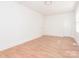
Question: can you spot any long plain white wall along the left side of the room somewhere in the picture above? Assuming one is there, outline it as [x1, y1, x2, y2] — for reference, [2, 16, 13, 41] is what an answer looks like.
[0, 2, 43, 50]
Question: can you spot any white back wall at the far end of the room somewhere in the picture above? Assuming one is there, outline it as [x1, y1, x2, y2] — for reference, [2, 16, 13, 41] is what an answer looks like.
[45, 12, 75, 37]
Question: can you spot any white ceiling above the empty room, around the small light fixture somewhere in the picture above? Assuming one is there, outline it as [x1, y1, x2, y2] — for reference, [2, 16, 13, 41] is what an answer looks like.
[20, 1, 76, 15]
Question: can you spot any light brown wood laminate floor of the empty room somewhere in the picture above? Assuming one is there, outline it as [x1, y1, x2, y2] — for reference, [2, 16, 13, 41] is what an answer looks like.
[0, 36, 79, 58]
